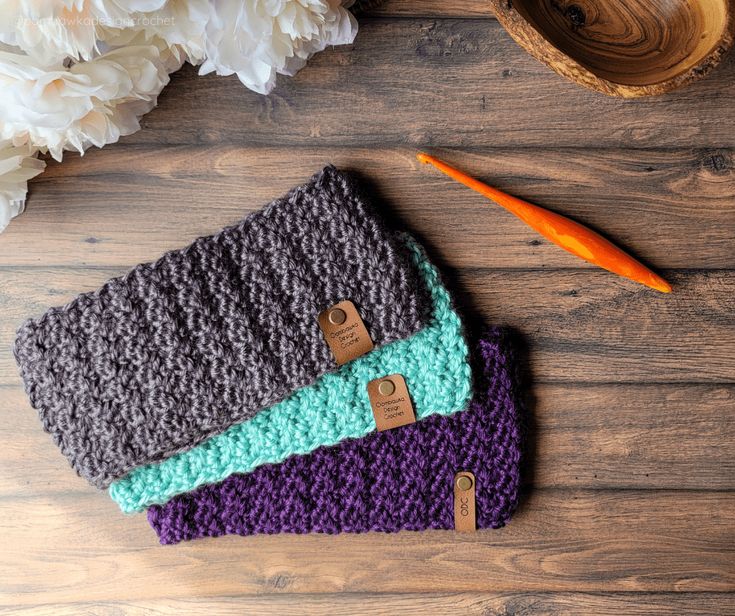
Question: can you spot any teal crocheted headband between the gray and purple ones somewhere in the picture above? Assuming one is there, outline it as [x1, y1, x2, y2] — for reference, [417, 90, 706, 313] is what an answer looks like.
[110, 236, 472, 512]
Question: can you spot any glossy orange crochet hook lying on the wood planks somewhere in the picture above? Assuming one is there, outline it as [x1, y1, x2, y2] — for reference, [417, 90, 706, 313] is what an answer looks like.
[416, 152, 671, 293]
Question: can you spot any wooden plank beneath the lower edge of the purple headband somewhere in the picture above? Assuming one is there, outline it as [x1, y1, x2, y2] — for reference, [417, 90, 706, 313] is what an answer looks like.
[0, 489, 735, 605]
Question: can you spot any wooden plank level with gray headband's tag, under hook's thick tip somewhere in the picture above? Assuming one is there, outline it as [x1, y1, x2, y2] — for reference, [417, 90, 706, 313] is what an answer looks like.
[0, 268, 735, 384]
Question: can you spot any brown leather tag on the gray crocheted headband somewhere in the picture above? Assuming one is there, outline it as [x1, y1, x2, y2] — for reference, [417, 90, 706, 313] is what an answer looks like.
[319, 300, 374, 366]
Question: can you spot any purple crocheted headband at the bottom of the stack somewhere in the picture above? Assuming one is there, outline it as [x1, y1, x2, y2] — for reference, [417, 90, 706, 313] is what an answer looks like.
[148, 330, 521, 544]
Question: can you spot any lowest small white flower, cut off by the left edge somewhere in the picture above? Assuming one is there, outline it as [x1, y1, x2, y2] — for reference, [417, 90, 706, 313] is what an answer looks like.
[0, 141, 46, 231]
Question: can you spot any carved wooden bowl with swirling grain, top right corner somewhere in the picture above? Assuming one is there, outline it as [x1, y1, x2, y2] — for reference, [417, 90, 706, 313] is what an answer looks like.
[490, 0, 735, 97]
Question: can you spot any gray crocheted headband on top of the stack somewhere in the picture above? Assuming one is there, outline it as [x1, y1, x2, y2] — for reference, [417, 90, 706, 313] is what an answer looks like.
[14, 167, 430, 488]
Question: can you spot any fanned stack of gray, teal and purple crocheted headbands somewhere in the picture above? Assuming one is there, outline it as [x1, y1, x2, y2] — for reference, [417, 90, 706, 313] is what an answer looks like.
[14, 167, 520, 543]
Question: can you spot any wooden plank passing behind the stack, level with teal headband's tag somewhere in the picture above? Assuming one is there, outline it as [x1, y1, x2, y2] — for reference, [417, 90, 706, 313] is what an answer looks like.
[0, 383, 735, 502]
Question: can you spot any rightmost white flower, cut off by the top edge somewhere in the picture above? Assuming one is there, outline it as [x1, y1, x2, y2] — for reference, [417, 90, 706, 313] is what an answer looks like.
[200, 0, 357, 94]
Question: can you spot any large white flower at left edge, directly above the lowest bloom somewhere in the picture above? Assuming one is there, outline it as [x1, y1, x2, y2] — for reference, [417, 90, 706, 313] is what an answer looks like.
[0, 35, 181, 160]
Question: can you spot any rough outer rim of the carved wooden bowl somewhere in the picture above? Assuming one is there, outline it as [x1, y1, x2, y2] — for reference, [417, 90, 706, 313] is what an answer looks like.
[489, 0, 735, 98]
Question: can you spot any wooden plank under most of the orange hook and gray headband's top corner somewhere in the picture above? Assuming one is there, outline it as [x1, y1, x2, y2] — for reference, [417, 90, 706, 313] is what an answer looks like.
[0, 145, 735, 270]
